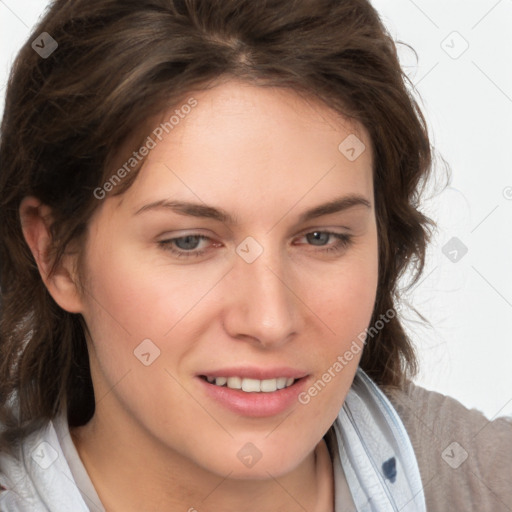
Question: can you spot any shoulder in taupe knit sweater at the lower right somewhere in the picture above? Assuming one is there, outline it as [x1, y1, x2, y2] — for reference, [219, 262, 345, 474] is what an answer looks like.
[381, 382, 512, 512]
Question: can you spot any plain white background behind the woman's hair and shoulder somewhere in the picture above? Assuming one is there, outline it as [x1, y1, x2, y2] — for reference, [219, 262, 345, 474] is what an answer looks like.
[0, 0, 512, 418]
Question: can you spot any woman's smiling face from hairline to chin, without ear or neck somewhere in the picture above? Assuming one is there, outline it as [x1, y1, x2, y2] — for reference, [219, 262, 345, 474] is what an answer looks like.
[78, 77, 378, 478]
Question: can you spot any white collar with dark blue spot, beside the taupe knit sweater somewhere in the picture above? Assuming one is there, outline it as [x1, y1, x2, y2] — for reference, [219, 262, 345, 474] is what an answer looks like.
[332, 368, 426, 512]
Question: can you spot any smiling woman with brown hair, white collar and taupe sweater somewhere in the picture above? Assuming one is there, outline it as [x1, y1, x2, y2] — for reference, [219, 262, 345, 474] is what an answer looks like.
[0, 0, 512, 512]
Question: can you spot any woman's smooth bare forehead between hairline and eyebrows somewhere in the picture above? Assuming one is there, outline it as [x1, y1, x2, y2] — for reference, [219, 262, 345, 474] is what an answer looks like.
[108, 80, 373, 219]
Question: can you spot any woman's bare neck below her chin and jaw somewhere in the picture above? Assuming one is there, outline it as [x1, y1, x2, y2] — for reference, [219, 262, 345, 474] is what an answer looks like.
[71, 412, 334, 512]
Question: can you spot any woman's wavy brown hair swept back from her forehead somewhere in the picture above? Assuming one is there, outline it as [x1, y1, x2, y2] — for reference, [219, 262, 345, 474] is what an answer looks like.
[0, 0, 440, 445]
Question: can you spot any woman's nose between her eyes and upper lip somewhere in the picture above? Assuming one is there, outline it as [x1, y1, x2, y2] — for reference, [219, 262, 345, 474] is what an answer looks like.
[223, 243, 302, 348]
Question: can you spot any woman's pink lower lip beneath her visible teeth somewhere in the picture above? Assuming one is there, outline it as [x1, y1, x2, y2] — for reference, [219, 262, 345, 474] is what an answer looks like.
[197, 377, 307, 418]
